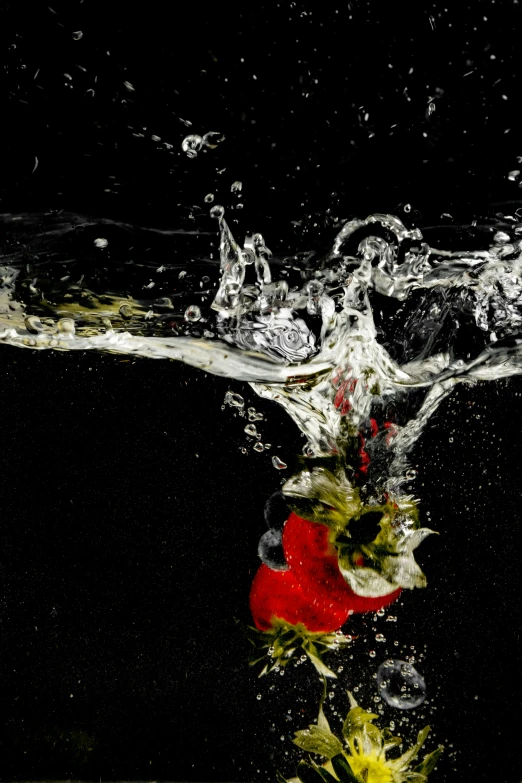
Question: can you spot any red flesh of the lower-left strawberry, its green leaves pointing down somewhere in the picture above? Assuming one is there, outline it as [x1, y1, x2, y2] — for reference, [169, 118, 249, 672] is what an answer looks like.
[250, 564, 348, 633]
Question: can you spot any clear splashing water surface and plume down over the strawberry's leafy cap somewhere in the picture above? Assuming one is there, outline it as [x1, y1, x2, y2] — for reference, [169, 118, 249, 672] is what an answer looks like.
[0, 208, 522, 596]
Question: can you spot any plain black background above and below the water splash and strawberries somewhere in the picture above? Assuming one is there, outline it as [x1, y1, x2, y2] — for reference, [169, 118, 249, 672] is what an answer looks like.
[0, 0, 522, 783]
